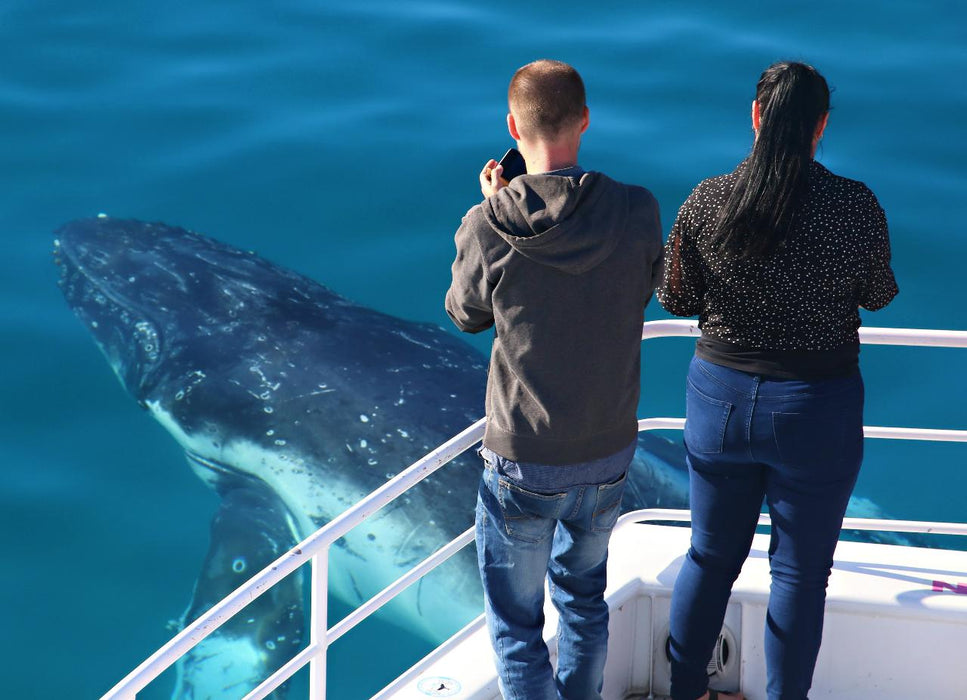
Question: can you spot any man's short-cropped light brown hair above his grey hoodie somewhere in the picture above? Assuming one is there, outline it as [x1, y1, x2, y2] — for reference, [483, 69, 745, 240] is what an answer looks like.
[507, 59, 586, 139]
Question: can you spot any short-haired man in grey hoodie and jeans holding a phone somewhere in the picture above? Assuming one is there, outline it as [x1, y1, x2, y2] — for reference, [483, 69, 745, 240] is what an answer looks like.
[446, 60, 662, 700]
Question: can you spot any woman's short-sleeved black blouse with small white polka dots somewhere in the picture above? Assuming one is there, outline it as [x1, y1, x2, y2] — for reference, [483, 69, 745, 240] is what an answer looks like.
[658, 161, 898, 350]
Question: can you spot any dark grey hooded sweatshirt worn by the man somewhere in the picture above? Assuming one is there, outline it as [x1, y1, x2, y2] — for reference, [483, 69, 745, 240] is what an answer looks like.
[446, 168, 662, 465]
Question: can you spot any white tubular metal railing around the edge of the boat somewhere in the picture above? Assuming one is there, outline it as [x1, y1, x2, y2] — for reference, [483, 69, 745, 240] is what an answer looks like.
[102, 320, 967, 700]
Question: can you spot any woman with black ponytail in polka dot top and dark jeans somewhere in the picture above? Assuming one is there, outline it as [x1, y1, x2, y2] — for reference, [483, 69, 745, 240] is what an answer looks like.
[658, 62, 897, 700]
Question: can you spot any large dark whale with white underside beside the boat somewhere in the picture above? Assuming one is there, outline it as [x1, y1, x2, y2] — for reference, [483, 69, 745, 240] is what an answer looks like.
[54, 216, 687, 699]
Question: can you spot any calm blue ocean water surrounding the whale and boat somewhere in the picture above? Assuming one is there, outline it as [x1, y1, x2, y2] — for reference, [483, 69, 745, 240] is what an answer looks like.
[0, 0, 967, 699]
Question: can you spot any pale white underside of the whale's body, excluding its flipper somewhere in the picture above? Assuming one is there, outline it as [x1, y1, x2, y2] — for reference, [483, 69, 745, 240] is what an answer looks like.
[147, 401, 482, 643]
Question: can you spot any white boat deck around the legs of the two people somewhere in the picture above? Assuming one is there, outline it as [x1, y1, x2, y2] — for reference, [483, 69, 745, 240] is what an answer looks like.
[376, 519, 967, 700]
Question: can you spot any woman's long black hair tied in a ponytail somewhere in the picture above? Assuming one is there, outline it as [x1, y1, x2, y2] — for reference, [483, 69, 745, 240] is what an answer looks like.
[713, 61, 829, 258]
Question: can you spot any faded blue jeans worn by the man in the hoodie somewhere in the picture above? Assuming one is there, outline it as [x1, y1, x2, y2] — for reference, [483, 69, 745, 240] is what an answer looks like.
[476, 443, 635, 700]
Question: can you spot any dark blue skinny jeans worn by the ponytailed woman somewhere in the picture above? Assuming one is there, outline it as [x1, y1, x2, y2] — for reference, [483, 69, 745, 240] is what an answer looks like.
[670, 357, 863, 700]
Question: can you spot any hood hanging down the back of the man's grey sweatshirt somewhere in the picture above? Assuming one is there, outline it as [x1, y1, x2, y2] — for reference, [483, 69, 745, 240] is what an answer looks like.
[483, 172, 629, 275]
